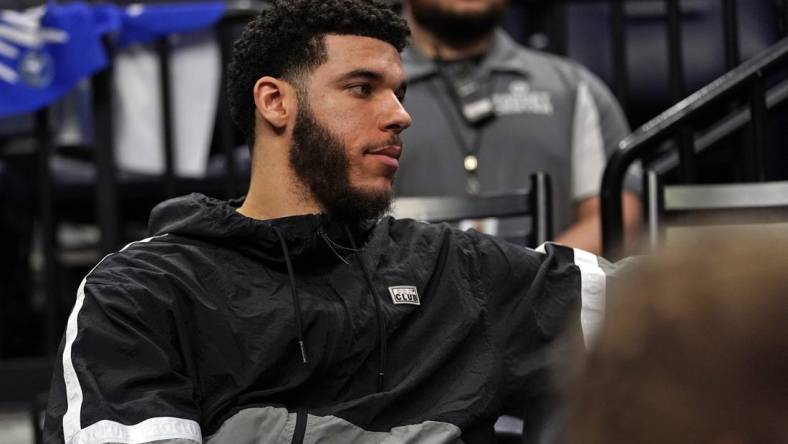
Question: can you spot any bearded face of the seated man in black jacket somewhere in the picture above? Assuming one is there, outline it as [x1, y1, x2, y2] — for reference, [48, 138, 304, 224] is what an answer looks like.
[290, 35, 410, 218]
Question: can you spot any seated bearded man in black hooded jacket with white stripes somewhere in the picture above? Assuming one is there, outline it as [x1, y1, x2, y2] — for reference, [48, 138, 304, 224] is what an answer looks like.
[44, 0, 620, 444]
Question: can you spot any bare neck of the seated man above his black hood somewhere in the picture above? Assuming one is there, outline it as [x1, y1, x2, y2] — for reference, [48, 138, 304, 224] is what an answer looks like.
[238, 150, 323, 220]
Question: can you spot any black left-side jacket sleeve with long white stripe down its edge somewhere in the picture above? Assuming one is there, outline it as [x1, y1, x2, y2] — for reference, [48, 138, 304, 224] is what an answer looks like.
[44, 273, 202, 444]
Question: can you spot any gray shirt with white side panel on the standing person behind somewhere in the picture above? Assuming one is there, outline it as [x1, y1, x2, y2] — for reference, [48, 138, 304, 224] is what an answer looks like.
[395, 30, 637, 234]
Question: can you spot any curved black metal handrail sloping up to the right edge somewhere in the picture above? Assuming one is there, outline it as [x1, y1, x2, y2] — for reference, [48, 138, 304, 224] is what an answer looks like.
[600, 38, 788, 255]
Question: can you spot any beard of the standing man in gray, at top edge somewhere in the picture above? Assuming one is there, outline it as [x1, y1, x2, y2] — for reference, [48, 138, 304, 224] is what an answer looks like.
[410, 0, 507, 45]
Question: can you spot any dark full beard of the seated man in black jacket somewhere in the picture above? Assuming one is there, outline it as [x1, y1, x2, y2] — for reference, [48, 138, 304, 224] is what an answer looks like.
[290, 98, 392, 222]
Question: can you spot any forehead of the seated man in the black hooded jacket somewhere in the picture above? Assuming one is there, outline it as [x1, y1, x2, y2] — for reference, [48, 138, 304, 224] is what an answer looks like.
[323, 34, 404, 80]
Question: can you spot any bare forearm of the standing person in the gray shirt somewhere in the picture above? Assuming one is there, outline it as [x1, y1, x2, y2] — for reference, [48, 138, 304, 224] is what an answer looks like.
[555, 191, 642, 254]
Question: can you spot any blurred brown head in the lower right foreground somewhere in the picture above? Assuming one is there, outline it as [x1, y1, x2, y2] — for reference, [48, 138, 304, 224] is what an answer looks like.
[565, 232, 788, 444]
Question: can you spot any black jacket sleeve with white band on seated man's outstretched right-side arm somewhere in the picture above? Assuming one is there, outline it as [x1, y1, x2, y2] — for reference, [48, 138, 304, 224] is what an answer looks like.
[474, 240, 615, 406]
